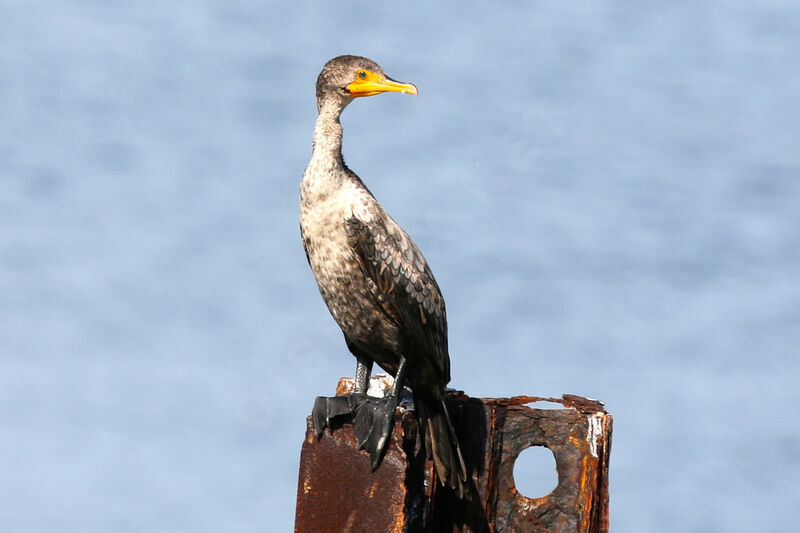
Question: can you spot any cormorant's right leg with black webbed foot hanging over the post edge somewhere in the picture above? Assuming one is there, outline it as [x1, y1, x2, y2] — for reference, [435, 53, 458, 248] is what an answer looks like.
[353, 357, 407, 471]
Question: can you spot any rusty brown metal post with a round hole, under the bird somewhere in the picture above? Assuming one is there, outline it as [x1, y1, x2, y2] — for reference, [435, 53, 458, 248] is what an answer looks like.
[295, 377, 612, 533]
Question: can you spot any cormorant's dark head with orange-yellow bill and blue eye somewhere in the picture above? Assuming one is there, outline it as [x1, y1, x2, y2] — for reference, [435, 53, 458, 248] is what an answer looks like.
[317, 56, 417, 109]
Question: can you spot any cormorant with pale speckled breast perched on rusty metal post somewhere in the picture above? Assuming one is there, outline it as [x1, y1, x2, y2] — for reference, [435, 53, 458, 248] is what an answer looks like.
[300, 55, 467, 498]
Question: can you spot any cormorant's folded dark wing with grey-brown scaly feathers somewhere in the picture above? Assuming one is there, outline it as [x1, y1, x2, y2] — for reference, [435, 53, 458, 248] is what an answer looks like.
[345, 213, 450, 384]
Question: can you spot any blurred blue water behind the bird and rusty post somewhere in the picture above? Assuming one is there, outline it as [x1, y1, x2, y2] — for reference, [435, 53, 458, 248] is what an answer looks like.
[0, 0, 800, 533]
